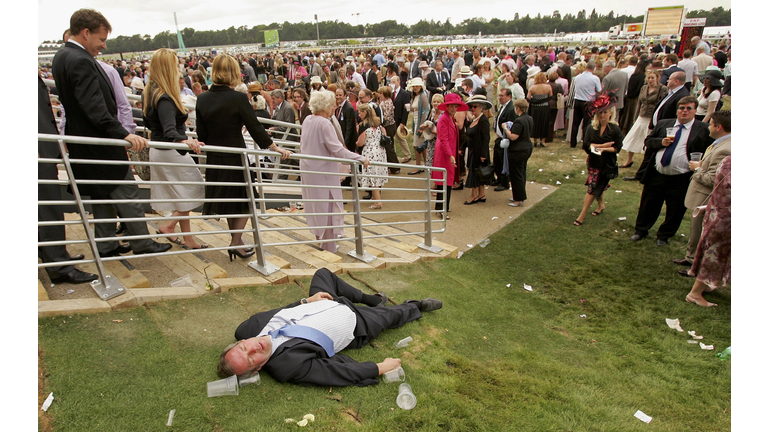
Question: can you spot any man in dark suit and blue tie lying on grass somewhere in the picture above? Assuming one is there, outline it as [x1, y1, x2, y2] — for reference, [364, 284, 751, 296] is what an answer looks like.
[218, 268, 443, 386]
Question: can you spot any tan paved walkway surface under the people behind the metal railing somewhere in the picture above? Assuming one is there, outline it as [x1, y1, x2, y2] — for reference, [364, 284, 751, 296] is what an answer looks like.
[38, 165, 554, 317]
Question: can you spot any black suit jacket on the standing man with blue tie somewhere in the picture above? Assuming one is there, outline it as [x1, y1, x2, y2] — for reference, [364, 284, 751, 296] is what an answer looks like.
[640, 118, 714, 185]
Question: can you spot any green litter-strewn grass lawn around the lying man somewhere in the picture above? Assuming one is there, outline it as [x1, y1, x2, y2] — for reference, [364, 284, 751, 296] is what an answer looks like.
[39, 139, 731, 432]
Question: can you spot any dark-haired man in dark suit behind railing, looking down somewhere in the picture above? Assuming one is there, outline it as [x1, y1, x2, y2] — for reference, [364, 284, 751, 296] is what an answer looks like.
[53, 9, 171, 257]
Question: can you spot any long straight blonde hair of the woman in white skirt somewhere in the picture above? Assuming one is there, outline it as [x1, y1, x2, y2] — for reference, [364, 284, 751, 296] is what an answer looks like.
[143, 48, 187, 115]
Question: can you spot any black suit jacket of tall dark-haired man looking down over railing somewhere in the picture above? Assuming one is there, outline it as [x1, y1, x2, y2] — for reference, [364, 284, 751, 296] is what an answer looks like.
[53, 42, 130, 198]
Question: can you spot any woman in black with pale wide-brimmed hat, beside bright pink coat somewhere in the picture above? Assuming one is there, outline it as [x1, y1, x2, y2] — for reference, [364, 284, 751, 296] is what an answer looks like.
[464, 95, 491, 205]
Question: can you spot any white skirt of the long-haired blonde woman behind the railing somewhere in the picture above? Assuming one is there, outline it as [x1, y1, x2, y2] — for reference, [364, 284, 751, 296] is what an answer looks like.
[149, 148, 205, 212]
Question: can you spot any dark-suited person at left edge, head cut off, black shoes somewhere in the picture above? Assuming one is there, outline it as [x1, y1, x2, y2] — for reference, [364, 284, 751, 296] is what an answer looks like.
[37, 77, 99, 284]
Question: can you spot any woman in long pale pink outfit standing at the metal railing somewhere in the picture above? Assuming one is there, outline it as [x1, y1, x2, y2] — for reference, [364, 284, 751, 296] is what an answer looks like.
[299, 90, 368, 253]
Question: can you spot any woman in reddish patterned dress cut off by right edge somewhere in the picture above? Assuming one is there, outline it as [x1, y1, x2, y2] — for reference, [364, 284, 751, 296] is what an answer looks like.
[685, 156, 731, 307]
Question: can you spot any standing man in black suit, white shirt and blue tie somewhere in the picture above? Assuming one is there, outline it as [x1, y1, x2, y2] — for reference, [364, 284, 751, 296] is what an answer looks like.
[631, 98, 713, 246]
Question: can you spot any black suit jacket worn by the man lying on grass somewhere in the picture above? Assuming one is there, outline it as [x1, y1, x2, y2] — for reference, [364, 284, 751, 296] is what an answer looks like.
[235, 297, 379, 386]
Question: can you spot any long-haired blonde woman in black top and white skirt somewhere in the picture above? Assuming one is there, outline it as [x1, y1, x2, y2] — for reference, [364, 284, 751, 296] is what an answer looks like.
[143, 48, 208, 249]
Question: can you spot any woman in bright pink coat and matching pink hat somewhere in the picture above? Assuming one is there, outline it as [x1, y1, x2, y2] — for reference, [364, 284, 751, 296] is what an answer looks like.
[432, 93, 469, 220]
